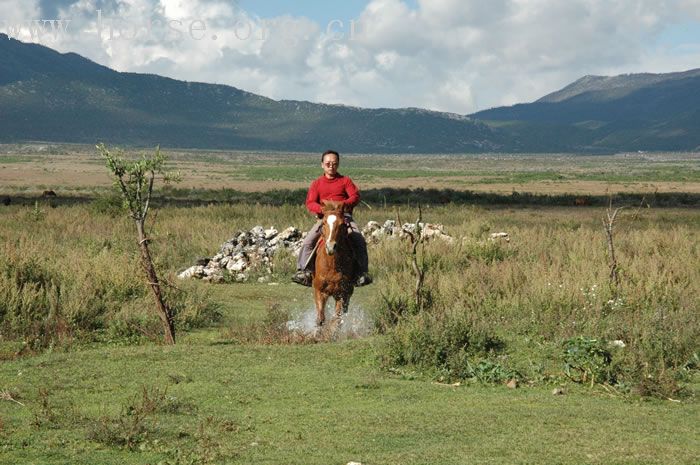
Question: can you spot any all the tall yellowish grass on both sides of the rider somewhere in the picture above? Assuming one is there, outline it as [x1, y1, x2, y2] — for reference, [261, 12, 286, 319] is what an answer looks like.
[0, 202, 700, 392]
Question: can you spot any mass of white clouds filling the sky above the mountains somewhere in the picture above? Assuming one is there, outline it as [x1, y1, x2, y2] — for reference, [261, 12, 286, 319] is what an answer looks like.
[5, 0, 700, 113]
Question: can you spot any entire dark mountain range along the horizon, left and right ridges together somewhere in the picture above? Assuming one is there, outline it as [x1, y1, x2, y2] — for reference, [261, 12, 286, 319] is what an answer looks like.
[0, 34, 700, 153]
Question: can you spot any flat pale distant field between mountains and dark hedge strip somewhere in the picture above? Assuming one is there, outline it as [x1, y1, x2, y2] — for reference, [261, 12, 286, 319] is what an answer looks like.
[0, 144, 700, 195]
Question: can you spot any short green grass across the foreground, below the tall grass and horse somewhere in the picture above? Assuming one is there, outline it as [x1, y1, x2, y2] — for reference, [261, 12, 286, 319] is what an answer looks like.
[0, 284, 700, 464]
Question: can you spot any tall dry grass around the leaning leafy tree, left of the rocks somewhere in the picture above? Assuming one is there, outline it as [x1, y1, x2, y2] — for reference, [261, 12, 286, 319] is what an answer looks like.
[0, 206, 218, 349]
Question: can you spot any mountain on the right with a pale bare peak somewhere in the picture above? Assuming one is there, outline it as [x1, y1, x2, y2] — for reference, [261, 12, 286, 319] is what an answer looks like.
[470, 69, 700, 152]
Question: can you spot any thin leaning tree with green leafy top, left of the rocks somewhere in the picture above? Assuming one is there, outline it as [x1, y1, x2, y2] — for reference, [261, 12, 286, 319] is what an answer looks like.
[97, 144, 180, 344]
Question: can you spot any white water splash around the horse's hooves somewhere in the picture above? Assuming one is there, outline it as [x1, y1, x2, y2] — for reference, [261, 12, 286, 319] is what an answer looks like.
[287, 301, 372, 340]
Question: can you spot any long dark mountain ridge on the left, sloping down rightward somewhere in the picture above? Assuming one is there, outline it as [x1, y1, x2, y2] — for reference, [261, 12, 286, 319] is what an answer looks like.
[0, 35, 503, 152]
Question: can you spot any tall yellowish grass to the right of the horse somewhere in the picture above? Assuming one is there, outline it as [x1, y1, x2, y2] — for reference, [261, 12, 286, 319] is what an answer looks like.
[373, 208, 700, 395]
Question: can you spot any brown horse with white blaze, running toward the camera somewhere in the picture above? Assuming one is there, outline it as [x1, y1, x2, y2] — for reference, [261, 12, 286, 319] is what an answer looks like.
[313, 200, 357, 326]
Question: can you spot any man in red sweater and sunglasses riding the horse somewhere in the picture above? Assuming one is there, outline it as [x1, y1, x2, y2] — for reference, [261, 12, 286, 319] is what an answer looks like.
[292, 150, 372, 286]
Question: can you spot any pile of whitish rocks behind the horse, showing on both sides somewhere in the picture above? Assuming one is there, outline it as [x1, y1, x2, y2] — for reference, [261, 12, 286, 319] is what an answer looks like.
[178, 220, 452, 283]
